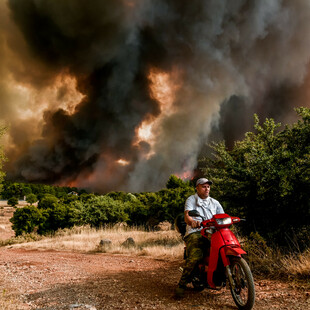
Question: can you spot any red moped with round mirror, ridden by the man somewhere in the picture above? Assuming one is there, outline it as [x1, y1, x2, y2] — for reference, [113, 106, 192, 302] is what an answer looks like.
[179, 210, 255, 310]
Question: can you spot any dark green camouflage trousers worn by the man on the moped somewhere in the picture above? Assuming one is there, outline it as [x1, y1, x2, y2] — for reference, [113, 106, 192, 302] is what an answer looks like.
[179, 231, 210, 286]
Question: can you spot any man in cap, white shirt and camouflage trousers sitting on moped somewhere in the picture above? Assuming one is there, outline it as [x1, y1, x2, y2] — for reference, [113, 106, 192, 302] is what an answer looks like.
[175, 178, 224, 298]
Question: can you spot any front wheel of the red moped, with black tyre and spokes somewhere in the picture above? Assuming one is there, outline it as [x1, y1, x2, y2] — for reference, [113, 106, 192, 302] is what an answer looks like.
[230, 257, 255, 310]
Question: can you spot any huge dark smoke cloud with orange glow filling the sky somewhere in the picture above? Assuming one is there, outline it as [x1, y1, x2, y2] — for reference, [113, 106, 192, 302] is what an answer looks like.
[0, 0, 310, 192]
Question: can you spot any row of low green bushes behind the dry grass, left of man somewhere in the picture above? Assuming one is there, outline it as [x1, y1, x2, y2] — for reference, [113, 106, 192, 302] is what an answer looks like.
[10, 176, 194, 234]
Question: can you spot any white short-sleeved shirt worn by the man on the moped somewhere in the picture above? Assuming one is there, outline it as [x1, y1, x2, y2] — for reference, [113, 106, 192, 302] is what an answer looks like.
[185, 194, 225, 237]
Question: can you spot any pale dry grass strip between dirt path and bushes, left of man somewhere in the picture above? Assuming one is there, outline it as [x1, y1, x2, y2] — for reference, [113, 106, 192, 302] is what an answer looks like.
[7, 227, 184, 259]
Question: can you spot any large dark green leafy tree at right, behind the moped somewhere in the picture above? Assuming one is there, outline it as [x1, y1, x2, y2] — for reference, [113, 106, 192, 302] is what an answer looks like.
[203, 108, 310, 245]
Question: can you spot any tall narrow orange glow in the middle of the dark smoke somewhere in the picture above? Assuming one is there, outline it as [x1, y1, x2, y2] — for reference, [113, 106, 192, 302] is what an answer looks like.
[134, 68, 180, 153]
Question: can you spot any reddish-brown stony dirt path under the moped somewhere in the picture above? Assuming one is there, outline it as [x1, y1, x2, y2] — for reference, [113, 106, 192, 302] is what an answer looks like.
[0, 248, 310, 310]
